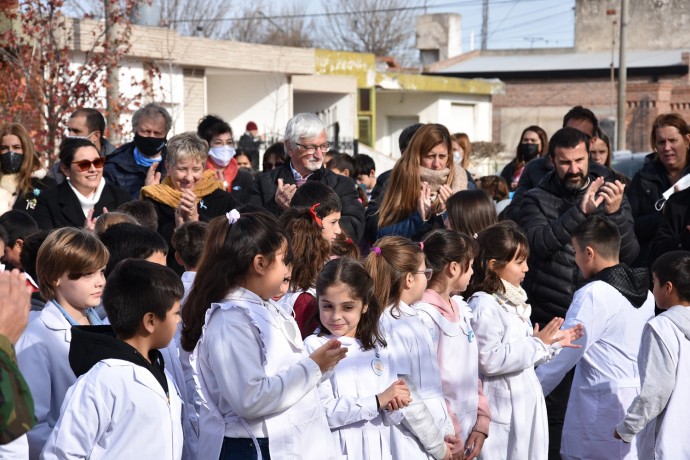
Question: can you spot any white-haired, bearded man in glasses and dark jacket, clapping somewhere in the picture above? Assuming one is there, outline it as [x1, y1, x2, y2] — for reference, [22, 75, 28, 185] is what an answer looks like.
[252, 113, 364, 241]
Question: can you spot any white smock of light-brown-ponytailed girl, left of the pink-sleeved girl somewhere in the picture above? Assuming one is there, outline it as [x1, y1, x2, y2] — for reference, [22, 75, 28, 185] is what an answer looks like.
[380, 302, 455, 460]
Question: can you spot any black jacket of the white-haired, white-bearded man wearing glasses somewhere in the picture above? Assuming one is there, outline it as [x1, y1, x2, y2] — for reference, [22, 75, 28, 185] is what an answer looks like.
[252, 163, 364, 241]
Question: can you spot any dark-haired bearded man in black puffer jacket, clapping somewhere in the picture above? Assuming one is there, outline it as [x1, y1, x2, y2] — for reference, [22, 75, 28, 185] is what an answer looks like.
[518, 127, 640, 458]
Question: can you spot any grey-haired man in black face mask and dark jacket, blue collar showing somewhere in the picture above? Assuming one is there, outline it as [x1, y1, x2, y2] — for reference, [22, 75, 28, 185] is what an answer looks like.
[103, 103, 172, 200]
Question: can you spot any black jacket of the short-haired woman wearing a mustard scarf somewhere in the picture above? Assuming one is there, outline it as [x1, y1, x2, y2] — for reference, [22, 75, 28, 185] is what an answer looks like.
[146, 190, 242, 274]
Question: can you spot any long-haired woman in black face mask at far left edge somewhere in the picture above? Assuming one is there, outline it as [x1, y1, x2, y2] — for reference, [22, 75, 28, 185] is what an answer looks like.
[0, 123, 55, 215]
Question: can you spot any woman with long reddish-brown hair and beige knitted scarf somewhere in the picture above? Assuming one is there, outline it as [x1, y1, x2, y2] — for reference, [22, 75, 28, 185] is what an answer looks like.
[366, 123, 474, 242]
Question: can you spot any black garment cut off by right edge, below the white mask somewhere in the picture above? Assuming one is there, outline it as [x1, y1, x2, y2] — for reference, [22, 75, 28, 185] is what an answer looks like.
[649, 188, 690, 260]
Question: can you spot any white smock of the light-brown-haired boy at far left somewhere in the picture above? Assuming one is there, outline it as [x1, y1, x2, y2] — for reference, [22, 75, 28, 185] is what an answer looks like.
[15, 302, 77, 460]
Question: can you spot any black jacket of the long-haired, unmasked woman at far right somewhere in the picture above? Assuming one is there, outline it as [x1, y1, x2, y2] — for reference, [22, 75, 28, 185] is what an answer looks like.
[626, 153, 690, 267]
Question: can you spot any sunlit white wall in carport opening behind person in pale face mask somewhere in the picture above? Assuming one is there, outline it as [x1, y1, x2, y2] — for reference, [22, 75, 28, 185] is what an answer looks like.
[206, 73, 292, 138]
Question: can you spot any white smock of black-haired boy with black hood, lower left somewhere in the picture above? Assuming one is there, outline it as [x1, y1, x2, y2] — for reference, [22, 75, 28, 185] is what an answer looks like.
[41, 359, 183, 460]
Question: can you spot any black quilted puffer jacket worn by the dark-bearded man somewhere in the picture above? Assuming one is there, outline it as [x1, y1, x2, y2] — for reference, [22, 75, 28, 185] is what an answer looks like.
[519, 171, 639, 323]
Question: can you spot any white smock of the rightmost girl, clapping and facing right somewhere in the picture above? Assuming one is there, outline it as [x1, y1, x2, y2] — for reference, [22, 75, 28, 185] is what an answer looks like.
[469, 292, 555, 460]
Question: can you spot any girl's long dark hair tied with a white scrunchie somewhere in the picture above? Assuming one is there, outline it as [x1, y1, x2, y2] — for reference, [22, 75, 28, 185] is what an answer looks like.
[181, 209, 289, 351]
